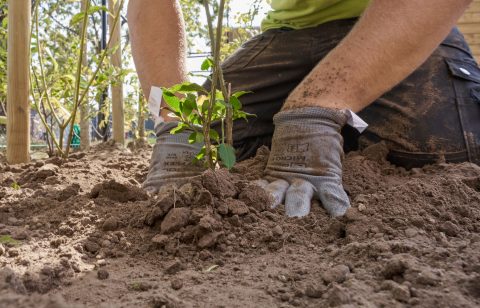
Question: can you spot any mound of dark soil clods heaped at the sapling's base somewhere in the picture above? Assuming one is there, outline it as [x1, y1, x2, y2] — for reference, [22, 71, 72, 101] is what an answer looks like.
[145, 170, 282, 253]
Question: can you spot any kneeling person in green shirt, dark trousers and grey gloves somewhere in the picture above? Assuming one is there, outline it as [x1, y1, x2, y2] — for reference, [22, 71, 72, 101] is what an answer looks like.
[128, 0, 480, 217]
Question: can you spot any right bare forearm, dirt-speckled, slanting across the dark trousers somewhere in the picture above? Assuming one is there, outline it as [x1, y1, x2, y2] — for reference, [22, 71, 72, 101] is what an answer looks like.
[284, 0, 471, 112]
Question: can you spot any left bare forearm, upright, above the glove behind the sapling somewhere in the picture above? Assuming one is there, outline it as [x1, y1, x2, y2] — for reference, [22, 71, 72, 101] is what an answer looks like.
[128, 0, 187, 97]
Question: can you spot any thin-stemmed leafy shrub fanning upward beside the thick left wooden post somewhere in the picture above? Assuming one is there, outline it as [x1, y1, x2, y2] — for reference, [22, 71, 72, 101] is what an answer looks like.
[31, 0, 127, 157]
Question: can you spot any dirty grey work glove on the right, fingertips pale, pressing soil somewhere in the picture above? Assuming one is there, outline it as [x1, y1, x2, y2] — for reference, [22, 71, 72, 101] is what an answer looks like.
[264, 107, 350, 217]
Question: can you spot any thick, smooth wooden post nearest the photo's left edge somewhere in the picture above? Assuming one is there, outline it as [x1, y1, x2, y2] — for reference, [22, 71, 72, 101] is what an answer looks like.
[7, 0, 32, 164]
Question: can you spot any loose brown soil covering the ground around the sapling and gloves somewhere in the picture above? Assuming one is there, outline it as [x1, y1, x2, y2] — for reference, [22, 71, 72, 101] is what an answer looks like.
[0, 145, 480, 307]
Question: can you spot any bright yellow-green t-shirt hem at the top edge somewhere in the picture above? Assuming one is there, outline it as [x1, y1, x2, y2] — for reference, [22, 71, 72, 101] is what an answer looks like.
[262, 0, 370, 31]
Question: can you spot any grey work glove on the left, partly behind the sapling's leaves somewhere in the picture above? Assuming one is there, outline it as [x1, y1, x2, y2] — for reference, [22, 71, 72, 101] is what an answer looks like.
[143, 122, 204, 193]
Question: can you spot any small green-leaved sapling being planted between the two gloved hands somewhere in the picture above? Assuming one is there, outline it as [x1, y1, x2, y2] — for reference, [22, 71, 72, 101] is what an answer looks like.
[163, 0, 252, 169]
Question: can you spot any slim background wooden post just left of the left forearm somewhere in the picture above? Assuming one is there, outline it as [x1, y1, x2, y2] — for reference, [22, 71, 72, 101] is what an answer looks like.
[108, 0, 125, 144]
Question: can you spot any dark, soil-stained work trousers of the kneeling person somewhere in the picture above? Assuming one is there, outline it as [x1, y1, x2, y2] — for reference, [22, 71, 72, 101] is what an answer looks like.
[208, 19, 480, 168]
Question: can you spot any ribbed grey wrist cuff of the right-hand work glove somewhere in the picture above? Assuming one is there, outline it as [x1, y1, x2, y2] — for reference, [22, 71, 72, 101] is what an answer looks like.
[273, 107, 348, 127]
